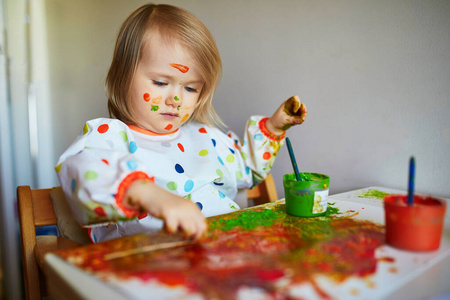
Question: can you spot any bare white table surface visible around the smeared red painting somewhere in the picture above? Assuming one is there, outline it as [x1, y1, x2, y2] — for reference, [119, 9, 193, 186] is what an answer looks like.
[45, 187, 450, 300]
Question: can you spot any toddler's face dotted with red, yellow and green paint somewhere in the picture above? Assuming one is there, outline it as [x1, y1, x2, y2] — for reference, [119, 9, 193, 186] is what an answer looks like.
[130, 34, 204, 133]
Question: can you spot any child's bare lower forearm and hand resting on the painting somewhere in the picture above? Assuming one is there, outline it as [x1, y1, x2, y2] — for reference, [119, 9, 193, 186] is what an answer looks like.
[124, 181, 207, 239]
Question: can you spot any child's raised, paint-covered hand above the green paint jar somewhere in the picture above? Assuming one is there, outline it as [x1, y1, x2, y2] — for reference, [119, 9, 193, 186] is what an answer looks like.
[266, 95, 307, 135]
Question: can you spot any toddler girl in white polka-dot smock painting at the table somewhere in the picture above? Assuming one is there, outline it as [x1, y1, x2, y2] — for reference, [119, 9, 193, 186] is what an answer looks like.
[56, 4, 306, 242]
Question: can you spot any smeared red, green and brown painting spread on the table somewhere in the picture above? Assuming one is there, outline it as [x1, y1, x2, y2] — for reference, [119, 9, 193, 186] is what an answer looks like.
[55, 202, 393, 299]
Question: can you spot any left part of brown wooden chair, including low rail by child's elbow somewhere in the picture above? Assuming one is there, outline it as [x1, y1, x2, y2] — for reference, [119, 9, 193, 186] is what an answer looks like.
[17, 186, 81, 300]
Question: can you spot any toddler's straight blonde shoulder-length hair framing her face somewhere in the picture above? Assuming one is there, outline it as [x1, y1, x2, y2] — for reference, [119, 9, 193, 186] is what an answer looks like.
[106, 4, 225, 128]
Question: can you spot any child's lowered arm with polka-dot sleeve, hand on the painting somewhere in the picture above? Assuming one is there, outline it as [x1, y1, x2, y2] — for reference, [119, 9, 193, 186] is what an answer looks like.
[56, 119, 206, 237]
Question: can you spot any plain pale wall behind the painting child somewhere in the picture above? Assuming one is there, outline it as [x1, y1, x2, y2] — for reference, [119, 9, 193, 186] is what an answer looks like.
[42, 0, 450, 197]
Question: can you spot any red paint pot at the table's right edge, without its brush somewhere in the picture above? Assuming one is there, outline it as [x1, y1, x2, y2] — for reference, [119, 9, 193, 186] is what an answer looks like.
[384, 195, 446, 251]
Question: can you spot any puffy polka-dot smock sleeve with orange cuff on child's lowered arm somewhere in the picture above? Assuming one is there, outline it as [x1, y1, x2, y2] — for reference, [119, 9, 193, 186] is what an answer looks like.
[55, 118, 154, 227]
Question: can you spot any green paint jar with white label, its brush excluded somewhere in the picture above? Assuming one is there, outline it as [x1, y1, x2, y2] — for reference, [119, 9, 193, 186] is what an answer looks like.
[283, 173, 330, 217]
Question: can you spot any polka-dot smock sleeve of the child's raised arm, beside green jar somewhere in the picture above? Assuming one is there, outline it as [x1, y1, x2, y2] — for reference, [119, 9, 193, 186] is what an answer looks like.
[228, 116, 285, 188]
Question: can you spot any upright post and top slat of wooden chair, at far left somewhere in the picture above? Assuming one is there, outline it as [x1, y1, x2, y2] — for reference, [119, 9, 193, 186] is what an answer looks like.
[17, 186, 57, 299]
